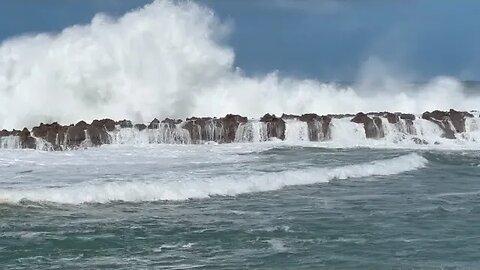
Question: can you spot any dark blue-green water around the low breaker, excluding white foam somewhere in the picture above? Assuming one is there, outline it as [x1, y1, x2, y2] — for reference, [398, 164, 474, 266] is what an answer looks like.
[0, 147, 480, 269]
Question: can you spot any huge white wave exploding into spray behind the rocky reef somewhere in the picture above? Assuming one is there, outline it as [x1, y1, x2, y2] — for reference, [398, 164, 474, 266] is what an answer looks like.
[0, 1, 480, 129]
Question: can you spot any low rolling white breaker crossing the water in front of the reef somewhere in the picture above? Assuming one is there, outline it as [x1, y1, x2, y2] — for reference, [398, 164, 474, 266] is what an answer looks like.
[0, 153, 428, 204]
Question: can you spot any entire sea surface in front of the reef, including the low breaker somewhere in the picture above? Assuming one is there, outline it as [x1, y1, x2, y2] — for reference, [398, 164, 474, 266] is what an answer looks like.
[0, 142, 480, 269]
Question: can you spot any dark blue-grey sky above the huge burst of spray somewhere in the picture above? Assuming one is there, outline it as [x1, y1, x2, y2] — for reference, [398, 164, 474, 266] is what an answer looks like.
[0, 0, 480, 81]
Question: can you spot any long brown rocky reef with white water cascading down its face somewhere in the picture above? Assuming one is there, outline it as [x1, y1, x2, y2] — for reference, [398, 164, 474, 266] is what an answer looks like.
[0, 109, 478, 151]
